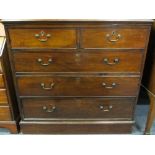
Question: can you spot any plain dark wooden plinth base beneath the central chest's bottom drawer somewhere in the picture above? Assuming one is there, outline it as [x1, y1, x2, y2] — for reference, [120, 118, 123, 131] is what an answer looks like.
[20, 121, 133, 134]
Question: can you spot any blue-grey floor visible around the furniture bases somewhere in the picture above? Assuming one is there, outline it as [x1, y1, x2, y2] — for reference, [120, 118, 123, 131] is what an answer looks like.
[0, 90, 155, 135]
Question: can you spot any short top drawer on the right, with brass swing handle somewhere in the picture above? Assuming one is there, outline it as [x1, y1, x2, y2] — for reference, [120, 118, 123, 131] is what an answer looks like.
[81, 28, 149, 48]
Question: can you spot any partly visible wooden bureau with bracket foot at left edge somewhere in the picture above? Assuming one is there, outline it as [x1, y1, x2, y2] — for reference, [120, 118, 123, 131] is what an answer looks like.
[0, 30, 19, 133]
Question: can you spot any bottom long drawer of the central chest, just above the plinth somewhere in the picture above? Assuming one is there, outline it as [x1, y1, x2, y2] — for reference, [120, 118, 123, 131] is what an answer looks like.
[21, 98, 135, 120]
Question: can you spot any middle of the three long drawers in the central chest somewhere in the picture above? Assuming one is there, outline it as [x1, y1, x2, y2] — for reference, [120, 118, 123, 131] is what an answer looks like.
[17, 76, 139, 96]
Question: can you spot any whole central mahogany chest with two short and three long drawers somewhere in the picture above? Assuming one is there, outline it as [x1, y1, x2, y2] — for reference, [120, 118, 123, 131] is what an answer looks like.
[4, 20, 151, 133]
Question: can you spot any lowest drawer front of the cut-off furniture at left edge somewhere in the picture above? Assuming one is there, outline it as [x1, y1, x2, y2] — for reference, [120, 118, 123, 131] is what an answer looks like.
[0, 106, 11, 121]
